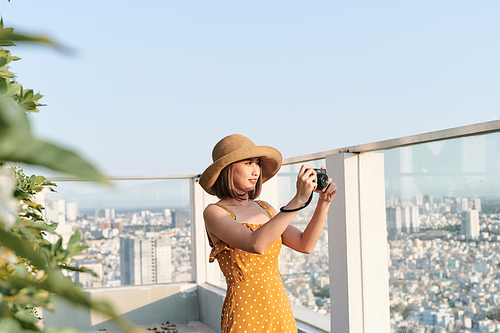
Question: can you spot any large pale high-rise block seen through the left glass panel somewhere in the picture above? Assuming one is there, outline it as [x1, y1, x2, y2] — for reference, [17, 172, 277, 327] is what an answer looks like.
[120, 232, 172, 286]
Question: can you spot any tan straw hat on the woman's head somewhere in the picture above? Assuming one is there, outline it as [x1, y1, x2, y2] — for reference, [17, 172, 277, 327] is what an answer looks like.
[200, 134, 282, 195]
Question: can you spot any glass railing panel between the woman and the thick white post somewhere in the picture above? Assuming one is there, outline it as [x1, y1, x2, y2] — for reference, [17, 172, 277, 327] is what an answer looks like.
[275, 159, 330, 315]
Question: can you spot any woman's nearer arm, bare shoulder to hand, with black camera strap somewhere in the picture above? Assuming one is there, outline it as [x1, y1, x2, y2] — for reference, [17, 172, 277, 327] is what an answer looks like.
[203, 166, 316, 254]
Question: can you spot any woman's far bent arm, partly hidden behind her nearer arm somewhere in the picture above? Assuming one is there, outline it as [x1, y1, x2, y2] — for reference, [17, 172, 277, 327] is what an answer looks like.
[282, 178, 337, 253]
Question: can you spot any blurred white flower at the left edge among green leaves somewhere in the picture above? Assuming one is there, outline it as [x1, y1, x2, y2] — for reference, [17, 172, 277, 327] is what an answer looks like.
[0, 166, 19, 228]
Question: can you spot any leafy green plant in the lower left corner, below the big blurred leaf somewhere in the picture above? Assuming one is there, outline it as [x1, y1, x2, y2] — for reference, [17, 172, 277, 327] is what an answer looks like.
[0, 168, 139, 332]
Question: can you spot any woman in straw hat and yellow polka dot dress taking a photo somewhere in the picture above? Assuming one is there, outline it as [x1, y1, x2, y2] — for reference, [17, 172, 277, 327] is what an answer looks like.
[200, 134, 337, 333]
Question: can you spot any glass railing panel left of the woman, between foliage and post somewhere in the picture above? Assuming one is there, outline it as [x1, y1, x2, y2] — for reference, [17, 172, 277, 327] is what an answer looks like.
[38, 178, 193, 288]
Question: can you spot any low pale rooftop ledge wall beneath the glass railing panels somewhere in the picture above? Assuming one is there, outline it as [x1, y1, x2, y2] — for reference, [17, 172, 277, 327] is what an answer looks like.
[40, 283, 330, 333]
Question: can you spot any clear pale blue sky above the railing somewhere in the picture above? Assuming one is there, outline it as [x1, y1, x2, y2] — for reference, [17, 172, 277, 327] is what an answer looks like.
[0, 0, 500, 176]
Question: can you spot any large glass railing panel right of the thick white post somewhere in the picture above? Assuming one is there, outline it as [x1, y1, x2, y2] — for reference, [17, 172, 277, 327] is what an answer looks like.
[384, 133, 500, 332]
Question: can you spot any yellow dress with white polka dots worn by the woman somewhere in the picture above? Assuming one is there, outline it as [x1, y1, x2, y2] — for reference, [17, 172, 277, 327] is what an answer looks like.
[210, 201, 297, 333]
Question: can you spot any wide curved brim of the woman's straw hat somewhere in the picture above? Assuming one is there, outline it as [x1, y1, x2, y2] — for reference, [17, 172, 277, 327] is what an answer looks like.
[200, 146, 283, 195]
